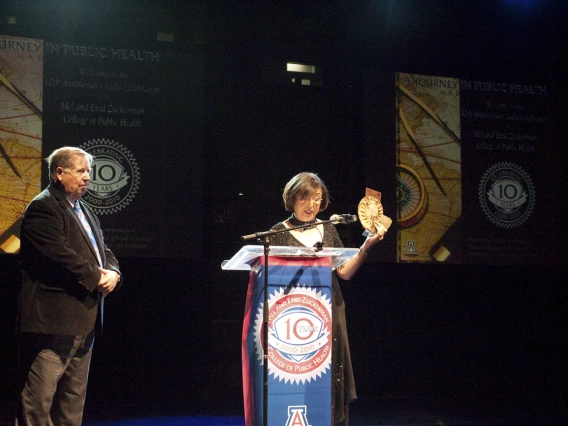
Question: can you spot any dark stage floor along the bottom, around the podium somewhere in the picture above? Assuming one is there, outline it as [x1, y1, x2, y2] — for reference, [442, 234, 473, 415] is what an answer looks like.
[0, 395, 568, 426]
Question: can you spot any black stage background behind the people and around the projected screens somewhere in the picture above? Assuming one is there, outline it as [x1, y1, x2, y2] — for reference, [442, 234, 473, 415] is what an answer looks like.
[0, 0, 568, 425]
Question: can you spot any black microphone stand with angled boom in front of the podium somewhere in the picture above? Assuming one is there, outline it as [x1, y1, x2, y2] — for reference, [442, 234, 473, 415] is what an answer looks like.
[241, 218, 347, 426]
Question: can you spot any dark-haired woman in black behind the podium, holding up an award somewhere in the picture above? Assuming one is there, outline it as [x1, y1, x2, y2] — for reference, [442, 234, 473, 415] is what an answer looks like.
[270, 172, 387, 424]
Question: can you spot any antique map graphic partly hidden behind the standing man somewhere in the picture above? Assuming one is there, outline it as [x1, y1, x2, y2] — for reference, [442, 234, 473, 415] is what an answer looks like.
[0, 36, 43, 253]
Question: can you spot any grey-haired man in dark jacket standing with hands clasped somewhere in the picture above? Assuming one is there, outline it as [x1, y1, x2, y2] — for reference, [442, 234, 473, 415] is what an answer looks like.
[16, 147, 121, 426]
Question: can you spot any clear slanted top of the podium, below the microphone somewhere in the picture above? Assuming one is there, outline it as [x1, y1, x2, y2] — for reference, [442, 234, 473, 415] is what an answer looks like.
[221, 245, 359, 271]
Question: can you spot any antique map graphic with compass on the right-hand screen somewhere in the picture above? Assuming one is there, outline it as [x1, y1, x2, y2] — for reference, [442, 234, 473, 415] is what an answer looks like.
[396, 73, 462, 262]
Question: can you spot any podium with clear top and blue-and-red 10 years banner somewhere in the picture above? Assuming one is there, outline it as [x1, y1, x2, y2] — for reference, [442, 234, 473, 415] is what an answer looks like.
[221, 245, 359, 426]
